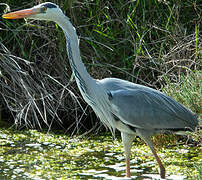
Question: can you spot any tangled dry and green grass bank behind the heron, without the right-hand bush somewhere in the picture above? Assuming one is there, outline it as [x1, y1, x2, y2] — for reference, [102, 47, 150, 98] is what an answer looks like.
[0, 0, 202, 132]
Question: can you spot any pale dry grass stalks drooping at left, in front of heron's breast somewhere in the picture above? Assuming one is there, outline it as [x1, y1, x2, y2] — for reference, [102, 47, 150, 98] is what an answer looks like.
[0, 41, 91, 131]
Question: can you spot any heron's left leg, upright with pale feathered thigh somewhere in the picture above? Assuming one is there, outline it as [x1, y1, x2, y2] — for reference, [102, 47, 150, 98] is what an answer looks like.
[121, 132, 134, 177]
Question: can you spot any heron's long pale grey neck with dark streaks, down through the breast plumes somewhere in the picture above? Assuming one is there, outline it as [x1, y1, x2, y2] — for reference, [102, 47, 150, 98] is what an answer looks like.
[57, 16, 115, 132]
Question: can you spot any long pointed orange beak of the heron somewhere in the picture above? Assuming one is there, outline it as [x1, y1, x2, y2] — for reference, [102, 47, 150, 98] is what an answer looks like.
[2, 8, 41, 19]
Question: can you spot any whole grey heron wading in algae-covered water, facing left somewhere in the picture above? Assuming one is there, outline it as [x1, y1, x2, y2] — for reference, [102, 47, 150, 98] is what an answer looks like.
[2, 2, 198, 178]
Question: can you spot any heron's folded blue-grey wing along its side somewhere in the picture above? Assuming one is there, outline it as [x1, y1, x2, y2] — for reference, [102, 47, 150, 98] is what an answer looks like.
[110, 88, 198, 129]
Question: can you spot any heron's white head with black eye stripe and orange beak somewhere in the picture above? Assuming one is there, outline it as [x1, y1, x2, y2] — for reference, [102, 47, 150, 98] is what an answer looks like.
[2, 2, 63, 21]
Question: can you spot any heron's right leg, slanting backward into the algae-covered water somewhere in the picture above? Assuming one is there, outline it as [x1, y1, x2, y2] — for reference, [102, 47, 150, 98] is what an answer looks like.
[139, 133, 166, 179]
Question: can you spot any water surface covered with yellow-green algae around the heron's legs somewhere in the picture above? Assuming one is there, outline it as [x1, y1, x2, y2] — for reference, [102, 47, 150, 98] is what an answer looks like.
[0, 129, 202, 179]
